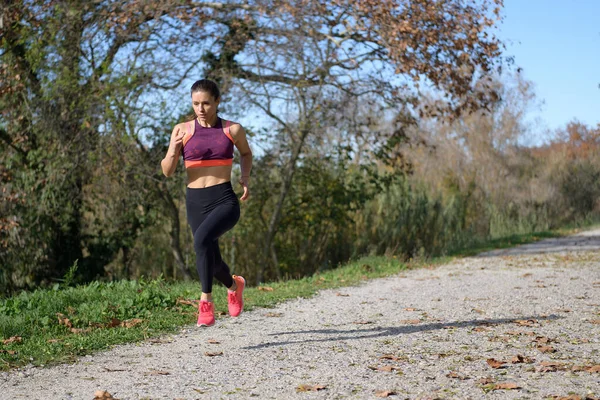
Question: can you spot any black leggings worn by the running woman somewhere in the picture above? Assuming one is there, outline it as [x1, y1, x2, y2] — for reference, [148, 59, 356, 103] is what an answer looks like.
[185, 182, 240, 293]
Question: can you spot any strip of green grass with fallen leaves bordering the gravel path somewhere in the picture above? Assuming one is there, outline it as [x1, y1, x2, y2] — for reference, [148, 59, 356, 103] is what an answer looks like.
[0, 227, 572, 370]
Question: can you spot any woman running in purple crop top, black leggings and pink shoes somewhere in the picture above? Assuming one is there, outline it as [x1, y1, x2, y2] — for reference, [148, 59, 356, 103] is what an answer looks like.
[160, 79, 252, 326]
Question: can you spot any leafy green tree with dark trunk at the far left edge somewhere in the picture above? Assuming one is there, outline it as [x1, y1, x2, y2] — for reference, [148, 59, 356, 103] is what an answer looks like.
[0, 0, 213, 286]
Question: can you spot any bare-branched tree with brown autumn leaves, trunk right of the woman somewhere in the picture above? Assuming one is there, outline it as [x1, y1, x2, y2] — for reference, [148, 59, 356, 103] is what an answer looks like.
[197, 0, 502, 281]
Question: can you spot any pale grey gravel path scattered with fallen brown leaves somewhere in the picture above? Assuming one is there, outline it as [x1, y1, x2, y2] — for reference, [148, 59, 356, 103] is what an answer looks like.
[0, 230, 600, 400]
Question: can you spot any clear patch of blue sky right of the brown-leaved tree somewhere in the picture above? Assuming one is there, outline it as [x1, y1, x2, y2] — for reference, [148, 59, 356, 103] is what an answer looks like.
[499, 0, 600, 138]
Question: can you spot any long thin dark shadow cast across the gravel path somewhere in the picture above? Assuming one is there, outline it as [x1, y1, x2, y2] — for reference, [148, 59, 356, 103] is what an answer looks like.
[244, 314, 563, 350]
